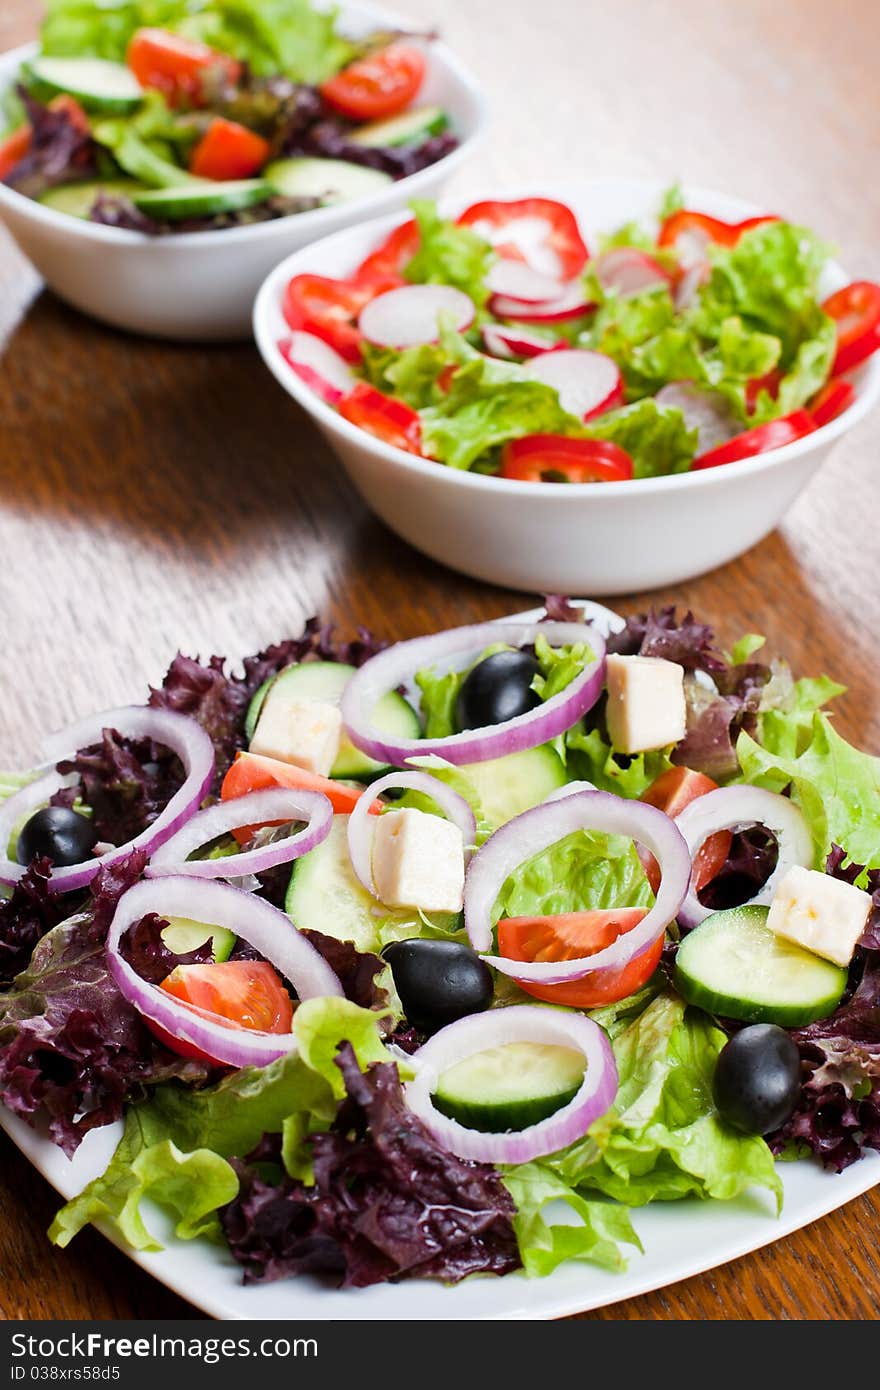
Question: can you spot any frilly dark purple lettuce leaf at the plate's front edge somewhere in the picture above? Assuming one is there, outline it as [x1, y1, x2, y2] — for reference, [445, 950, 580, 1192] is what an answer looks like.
[221, 1044, 520, 1287]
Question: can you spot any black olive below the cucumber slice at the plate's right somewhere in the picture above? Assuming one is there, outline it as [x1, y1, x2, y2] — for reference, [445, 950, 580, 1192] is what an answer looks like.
[713, 1023, 801, 1134]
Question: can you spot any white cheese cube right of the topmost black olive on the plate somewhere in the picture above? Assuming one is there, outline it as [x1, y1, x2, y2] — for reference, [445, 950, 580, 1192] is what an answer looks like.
[606, 655, 687, 753]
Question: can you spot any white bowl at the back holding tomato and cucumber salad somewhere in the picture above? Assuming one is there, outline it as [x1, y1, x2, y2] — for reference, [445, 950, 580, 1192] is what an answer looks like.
[0, 12, 487, 341]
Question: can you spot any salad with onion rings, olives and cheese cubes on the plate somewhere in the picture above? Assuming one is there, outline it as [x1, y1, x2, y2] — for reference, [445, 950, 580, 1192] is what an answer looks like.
[0, 598, 880, 1287]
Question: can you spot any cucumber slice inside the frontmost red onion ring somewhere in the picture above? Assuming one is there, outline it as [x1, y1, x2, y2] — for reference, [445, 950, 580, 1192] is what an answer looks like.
[434, 1043, 584, 1134]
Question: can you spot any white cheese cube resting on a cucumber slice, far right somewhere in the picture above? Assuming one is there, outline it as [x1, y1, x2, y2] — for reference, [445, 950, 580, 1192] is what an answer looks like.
[767, 865, 872, 965]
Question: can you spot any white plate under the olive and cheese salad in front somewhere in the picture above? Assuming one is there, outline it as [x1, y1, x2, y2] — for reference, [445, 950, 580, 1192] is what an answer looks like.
[0, 605, 880, 1321]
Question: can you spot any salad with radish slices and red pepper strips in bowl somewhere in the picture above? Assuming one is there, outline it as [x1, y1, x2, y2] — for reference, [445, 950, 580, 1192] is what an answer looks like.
[278, 189, 880, 482]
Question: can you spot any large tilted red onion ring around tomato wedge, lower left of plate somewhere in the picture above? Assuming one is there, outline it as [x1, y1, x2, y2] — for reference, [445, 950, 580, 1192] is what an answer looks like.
[107, 877, 343, 1066]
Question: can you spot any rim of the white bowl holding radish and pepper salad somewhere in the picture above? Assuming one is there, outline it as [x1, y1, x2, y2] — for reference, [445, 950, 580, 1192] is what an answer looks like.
[253, 177, 880, 500]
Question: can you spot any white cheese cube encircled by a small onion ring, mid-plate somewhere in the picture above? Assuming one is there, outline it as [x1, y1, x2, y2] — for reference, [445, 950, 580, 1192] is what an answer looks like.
[373, 808, 464, 912]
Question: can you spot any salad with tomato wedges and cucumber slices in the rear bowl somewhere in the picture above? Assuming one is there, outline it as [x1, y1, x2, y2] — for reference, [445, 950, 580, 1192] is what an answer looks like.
[0, 0, 457, 235]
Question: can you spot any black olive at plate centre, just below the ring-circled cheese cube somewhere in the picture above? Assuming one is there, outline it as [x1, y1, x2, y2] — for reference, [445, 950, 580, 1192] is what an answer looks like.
[382, 940, 492, 1033]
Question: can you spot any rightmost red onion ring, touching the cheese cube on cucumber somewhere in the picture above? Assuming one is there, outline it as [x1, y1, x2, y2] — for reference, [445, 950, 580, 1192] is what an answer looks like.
[676, 787, 815, 927]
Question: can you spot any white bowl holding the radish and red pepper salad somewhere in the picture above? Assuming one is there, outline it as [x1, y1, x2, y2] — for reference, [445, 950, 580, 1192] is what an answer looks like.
[254, 179, 880, 595]
